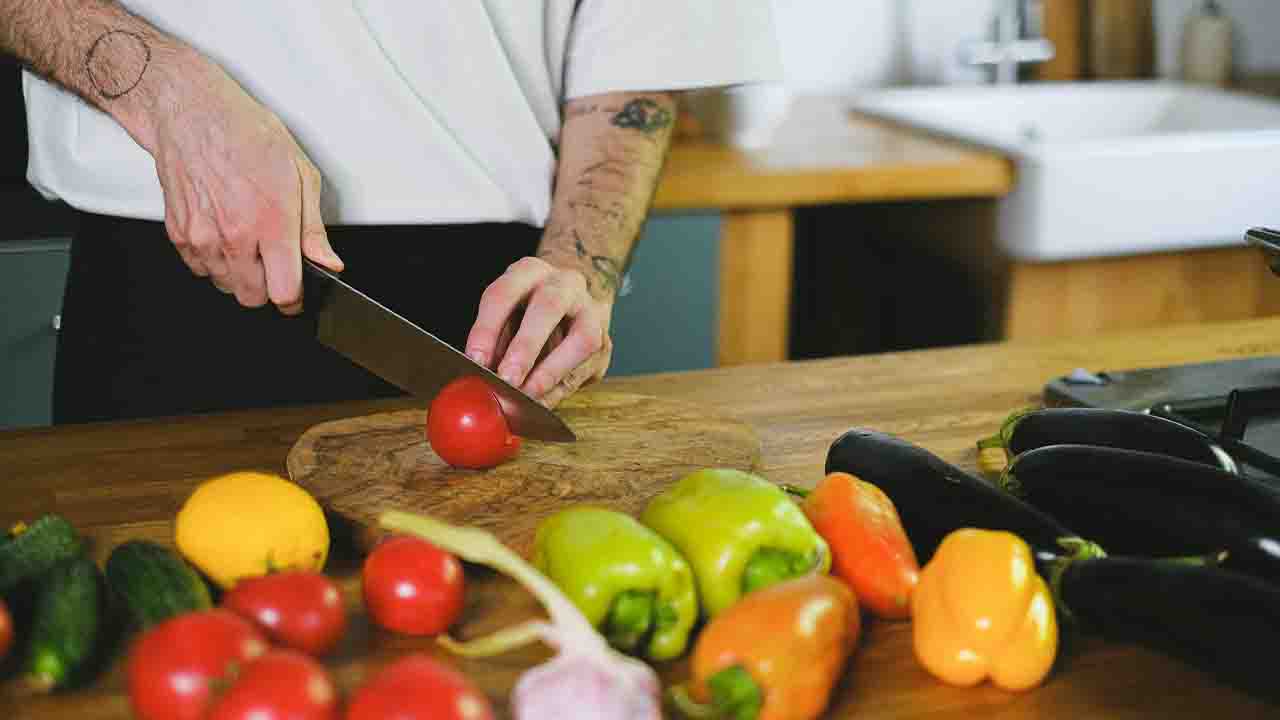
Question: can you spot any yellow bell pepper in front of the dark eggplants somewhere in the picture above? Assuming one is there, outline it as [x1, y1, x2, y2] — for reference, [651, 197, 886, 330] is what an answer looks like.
[911, 528, 1057, 691]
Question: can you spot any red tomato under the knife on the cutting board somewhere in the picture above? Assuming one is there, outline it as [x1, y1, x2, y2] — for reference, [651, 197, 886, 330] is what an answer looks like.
[426, 375, 520, 470]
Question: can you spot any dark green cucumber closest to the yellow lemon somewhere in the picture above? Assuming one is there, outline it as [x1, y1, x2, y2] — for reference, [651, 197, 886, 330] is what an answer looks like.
[106, 539, 212, 628]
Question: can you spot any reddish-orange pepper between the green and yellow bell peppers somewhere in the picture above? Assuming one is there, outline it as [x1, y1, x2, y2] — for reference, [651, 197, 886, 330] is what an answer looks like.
[787, 473, 920, 620]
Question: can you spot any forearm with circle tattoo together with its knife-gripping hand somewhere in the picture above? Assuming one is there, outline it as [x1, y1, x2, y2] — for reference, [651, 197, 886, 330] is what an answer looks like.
[0, 0, 342, 314]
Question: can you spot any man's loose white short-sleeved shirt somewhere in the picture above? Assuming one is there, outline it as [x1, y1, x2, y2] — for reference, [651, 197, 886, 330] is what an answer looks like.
[23, 0, 781, 225]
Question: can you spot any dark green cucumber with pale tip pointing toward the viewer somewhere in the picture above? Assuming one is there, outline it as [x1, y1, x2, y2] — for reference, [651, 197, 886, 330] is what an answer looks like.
[24, 555, 105, 692]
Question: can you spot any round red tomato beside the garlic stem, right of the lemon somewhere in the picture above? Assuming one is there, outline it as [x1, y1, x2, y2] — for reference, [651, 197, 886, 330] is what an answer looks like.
[360, 536, 463, 635]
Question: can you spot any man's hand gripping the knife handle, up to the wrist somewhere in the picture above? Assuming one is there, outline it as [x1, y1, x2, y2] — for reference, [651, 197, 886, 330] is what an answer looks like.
[147, 54, 343, 315]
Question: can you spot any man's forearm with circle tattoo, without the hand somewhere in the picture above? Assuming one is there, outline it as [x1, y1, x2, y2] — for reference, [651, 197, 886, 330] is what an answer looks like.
[0, 0, 196, 147]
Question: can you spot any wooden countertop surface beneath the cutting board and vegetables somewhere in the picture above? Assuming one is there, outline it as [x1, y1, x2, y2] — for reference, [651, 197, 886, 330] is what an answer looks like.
[0, 320, 1280, 720]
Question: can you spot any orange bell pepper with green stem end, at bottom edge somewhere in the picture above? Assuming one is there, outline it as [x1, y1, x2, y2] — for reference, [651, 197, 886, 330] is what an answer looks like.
[672, 574, 861, 720]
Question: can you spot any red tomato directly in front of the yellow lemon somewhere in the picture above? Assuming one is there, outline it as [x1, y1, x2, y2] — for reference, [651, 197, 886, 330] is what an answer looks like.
[223, 570, 347, 656]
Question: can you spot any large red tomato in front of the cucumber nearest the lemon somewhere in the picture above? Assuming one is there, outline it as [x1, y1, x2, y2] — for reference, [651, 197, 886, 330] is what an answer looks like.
[127, 607, 266, 720]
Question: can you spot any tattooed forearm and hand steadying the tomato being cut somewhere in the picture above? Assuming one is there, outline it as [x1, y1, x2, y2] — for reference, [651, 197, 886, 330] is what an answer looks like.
[466, 92, 676, 407]
